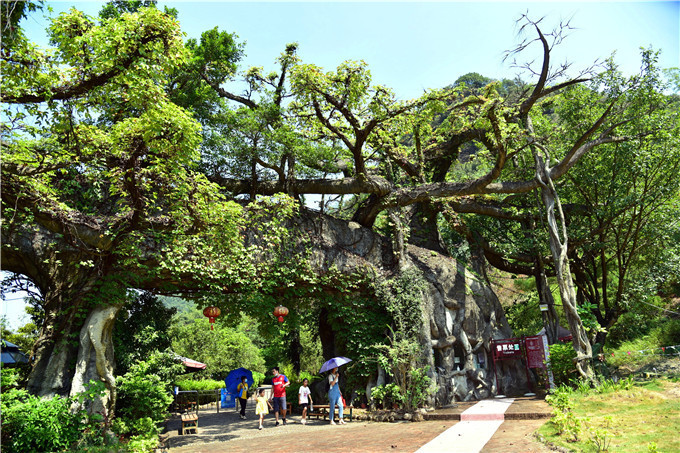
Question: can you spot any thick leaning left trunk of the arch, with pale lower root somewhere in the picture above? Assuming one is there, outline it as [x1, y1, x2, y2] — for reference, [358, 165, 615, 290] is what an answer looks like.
[2, 222, 120, 413]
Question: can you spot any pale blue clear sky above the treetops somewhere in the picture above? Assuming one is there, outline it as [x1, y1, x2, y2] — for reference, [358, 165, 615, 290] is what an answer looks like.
[2, 1, 680, 328]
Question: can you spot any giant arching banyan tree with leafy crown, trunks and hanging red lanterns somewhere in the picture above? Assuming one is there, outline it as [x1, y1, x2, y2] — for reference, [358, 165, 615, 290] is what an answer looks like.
[0, 2, 676, 410]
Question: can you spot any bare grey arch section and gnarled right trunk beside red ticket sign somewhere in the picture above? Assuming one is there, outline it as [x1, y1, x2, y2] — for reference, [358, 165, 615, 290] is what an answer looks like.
[295, 211, 526, 405]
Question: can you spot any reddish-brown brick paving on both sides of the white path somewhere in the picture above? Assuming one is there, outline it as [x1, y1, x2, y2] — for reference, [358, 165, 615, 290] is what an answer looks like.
[165, 399, 549, 453]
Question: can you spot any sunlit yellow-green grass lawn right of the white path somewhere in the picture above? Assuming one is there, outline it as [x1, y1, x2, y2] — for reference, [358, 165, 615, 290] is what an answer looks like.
[538, 380, 680, 453]
